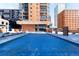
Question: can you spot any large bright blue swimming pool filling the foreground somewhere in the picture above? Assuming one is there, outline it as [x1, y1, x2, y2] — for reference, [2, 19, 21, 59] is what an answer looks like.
[0, 33, 79, 56]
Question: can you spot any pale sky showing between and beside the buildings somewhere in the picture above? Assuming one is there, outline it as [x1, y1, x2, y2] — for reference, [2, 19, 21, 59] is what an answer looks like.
[0, 3, 79, 27]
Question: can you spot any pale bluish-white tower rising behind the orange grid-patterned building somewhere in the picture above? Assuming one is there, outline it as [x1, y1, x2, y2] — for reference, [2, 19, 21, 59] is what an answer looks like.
[54, 3, 66, 28]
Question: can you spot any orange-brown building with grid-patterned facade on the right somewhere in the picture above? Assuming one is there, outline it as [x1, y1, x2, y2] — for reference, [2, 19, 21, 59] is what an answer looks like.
[58, 10, 79, 32]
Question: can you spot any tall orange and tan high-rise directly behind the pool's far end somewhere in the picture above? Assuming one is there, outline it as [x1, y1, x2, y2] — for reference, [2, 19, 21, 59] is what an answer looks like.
[17, 3, 51, 32]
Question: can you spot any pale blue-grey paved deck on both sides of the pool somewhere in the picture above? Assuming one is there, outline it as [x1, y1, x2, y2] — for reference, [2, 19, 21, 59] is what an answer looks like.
[0, 33, 79, 44]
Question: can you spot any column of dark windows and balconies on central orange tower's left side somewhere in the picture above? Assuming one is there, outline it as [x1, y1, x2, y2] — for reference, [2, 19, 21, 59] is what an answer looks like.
[19, 3, 29, 20]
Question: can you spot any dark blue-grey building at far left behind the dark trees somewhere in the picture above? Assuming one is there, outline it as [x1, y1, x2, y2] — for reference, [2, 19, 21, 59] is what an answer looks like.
[0, 9, 19, 21]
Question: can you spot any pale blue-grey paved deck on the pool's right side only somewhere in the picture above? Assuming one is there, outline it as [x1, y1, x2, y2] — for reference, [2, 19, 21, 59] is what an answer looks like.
[48, 34, 79, 44]
